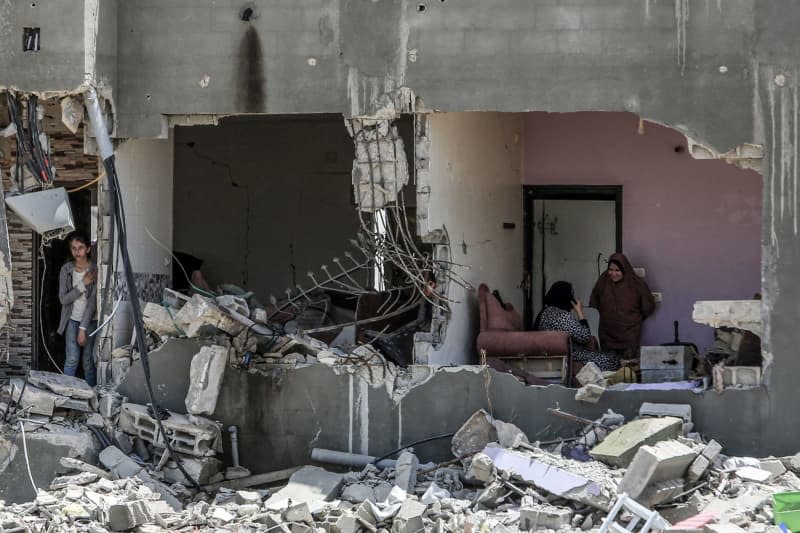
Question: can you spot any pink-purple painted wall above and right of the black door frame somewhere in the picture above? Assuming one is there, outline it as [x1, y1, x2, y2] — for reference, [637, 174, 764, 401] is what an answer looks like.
[523, 112, 762, 351]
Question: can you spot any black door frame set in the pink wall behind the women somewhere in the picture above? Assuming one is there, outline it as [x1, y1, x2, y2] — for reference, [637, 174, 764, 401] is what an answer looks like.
[522, 185, 622, 329]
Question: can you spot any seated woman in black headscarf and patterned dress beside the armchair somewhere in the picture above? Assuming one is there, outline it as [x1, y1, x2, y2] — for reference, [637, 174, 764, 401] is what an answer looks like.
[533, 281, 619, 370]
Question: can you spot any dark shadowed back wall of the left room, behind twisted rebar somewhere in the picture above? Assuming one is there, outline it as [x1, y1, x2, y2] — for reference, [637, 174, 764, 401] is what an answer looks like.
[173, 116, 358, 302]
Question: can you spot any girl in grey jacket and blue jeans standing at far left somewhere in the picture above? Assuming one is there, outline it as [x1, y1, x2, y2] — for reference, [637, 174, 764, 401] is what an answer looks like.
[58, 231, 97, 387]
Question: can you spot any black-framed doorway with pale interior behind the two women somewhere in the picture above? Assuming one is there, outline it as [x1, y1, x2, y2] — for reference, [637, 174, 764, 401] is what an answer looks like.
[524, 186, 622, 329]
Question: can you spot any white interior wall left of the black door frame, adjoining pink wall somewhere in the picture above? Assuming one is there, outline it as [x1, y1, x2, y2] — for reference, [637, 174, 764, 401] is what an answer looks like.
[418, 113, 523, 364]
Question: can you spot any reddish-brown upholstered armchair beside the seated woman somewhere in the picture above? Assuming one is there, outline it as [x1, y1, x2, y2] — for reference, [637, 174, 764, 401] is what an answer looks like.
[477, 283, 572, 385]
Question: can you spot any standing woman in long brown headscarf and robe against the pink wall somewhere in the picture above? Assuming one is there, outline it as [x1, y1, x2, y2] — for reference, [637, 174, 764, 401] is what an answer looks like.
[589, 253, 656, 359]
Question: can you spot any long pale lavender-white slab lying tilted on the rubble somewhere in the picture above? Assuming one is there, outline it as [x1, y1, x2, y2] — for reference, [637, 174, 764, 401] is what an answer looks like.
[483, 446, 611, 511]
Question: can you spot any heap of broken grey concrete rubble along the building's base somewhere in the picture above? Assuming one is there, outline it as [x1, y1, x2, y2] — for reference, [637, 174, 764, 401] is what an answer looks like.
[0, 376, 800, 533]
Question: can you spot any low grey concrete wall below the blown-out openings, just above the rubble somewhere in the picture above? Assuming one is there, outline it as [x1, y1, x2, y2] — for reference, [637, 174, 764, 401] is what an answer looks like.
[212, 365, 772, 472]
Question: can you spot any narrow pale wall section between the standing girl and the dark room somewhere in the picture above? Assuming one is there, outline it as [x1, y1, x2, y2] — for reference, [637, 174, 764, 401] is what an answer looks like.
[113, 139, 173, 346]
